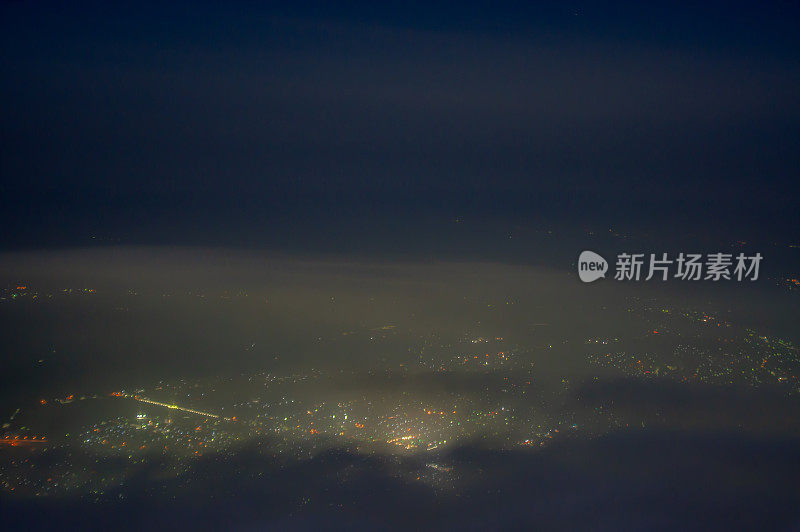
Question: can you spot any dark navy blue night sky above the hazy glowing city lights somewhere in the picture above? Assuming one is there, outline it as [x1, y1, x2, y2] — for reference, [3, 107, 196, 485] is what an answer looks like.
[0, 2, 800, 250]
